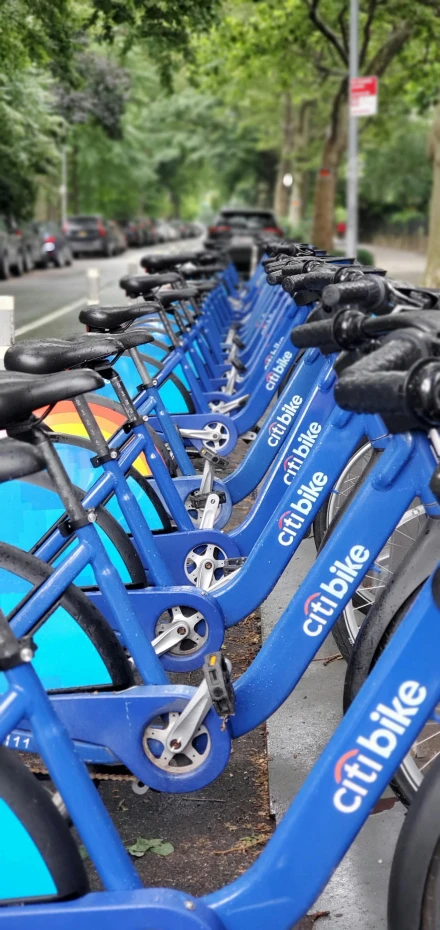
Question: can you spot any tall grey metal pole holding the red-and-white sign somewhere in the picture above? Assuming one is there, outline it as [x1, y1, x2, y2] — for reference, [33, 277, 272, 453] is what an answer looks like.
[346, 0, 359, 255]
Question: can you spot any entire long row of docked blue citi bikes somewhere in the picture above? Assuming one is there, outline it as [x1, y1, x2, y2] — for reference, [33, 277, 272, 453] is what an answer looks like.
[0, 240, 440, 930]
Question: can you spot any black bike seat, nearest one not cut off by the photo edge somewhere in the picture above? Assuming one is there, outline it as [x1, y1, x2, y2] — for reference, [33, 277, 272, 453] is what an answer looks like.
[5, 334, 121, 375]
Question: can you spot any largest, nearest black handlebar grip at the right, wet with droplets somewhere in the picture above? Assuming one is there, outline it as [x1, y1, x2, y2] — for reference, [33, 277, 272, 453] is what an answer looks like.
[335, 331, 425, 414]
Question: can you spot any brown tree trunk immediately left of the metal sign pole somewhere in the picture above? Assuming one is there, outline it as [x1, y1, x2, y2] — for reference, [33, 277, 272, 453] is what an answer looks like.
[312, 78, 347, 250]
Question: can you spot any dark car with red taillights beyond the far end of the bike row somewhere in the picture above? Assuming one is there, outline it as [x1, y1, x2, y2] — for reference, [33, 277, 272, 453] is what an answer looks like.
[208, 207, 283, 272]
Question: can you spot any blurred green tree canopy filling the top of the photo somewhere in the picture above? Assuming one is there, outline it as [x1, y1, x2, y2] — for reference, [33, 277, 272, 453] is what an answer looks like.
[0, 0, 440, 258]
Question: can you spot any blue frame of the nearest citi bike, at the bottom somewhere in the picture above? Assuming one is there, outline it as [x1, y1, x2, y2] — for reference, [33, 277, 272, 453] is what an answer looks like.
[0, 524, 440, 930]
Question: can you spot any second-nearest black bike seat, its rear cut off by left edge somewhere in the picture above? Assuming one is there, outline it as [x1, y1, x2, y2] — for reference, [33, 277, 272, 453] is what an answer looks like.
[0, 368, 104, 429]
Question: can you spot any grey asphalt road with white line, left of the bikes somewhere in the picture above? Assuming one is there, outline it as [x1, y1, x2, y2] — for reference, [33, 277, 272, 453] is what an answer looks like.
[0, 239, 201, 338]
